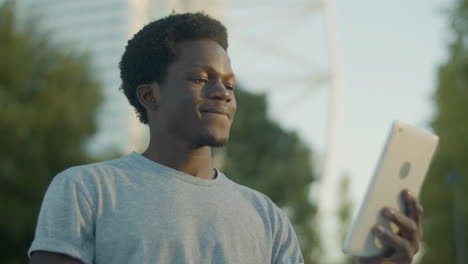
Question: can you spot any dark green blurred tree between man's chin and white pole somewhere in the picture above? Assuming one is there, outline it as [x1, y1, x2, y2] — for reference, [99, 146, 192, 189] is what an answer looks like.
[222, 89, 319, 263]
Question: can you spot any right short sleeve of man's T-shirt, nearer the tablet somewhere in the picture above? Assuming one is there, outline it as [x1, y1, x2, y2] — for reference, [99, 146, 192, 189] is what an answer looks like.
[272, 209, 304, 264]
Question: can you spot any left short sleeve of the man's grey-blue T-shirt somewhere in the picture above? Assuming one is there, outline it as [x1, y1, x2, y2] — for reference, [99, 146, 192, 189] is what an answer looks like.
[28, 173, 95, 263]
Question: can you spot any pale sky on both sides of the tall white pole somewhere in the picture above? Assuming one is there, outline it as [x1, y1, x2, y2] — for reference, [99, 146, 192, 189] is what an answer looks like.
[223, 0, 454, 260]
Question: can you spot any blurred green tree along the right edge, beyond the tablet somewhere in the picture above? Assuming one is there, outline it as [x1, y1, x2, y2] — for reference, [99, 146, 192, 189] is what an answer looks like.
[421, 0, 468, 264]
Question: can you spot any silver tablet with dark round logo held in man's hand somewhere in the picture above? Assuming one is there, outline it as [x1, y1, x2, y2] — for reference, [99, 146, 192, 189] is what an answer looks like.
[343, 121, 439, 257]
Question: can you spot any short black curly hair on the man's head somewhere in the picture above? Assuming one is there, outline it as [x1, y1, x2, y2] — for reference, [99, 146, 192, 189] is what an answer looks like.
[119, 12, 228, 124]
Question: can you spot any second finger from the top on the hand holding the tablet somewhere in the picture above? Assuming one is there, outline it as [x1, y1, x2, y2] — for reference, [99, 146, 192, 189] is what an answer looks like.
[382, 207, 419, 242]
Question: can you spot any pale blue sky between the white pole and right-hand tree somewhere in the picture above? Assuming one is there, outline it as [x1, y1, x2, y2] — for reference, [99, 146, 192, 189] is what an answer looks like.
[328, 0, 452, 202]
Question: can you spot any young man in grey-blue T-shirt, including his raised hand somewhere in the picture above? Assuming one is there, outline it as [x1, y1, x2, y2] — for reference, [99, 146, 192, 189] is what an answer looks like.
[29, 13, 420, 264]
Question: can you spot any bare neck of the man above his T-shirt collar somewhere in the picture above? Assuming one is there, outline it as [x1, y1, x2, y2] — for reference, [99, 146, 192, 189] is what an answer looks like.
[142, 128, 215, 179]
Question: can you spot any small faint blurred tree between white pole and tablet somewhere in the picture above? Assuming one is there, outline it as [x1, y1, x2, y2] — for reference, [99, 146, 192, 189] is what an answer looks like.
[338, 174, 355, 264]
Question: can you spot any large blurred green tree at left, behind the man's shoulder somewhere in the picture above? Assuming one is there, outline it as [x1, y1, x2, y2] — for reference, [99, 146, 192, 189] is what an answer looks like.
[0, 1, 101, 264]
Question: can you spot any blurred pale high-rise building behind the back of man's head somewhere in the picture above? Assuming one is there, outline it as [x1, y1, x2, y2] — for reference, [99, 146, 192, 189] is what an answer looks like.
[17, 0, 225, 154]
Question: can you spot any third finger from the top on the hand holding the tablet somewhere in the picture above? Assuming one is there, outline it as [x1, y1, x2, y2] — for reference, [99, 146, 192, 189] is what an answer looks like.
[373, 225, 414, 260]
